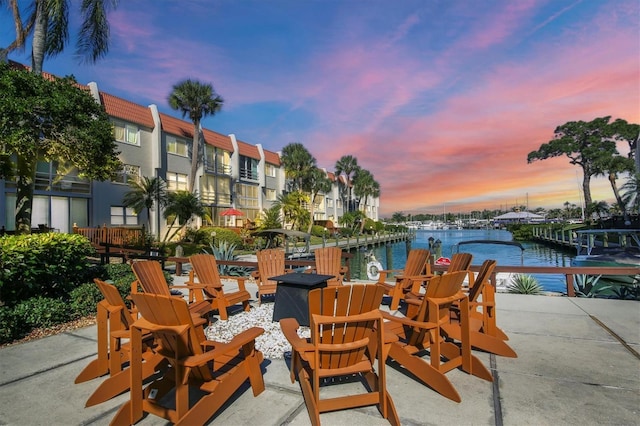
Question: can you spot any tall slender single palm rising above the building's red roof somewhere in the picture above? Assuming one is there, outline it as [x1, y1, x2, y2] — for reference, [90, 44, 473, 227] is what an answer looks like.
[168, 79, 224, 191]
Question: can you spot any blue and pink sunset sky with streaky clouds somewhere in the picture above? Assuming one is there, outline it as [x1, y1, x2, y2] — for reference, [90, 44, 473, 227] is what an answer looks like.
[0, 0, 640, 216]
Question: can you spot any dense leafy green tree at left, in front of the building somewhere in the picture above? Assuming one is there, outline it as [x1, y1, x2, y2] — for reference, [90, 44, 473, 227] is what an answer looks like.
[0, 64, 121, 233]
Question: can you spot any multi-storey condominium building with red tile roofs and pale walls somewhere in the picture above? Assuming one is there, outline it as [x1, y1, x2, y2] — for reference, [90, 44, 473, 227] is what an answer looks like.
[0, 64, 379, 235]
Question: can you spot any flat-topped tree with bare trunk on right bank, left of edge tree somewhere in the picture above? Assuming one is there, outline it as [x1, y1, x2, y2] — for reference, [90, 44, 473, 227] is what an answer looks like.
[527, 117, 619, 215]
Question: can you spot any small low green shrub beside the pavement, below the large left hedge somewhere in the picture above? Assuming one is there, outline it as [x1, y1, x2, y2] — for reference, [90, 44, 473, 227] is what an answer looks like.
[13, 296, 72, 329]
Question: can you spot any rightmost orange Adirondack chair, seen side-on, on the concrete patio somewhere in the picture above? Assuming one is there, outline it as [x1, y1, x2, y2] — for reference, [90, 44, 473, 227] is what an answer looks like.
[442, 260, 518, 358]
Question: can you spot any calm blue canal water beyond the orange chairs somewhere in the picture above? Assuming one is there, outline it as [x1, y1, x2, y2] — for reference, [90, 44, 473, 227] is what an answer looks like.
[351, 229, 574, 292]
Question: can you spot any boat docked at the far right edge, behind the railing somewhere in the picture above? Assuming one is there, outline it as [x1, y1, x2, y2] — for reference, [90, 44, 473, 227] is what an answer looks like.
[572, 229, 640, 284]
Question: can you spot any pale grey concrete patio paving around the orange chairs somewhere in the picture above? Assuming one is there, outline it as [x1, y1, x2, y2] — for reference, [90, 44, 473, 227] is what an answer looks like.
[0, 278, 640, 426]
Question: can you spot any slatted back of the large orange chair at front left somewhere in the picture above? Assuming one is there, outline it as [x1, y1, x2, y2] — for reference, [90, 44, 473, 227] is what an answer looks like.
[131, 293, 211, 381]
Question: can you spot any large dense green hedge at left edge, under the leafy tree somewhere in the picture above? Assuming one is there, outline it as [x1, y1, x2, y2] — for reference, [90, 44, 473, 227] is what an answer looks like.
[0, 232, 94, 306]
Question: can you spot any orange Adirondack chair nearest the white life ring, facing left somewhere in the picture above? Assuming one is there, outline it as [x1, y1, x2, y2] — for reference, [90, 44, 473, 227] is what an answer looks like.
[378, 249, 431, 310]
